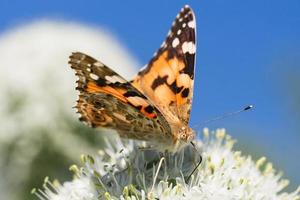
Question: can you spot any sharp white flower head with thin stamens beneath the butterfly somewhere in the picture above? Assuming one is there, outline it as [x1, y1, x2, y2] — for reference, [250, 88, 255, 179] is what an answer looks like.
[36, 129, 300, 200]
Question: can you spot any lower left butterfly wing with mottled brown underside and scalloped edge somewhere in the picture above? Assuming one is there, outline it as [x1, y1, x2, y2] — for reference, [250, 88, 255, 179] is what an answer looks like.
[69, 52, 171, 142]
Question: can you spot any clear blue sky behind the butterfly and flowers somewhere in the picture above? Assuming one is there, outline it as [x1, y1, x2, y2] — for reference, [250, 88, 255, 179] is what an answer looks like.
[0, 0, 300, 188]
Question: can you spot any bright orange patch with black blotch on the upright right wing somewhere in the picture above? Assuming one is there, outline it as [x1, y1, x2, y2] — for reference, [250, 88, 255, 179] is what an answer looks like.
[132, 51, 192, 107]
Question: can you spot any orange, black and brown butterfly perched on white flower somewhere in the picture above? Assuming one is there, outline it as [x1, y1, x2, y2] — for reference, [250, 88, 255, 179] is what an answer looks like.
[69, 6, 196, 152]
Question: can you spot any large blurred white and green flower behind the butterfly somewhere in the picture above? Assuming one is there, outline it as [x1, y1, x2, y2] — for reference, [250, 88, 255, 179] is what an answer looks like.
[0, 20, 137, 199]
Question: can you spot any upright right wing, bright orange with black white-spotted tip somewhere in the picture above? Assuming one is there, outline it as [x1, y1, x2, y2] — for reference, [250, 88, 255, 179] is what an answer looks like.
[132, 6, 196, 125]
